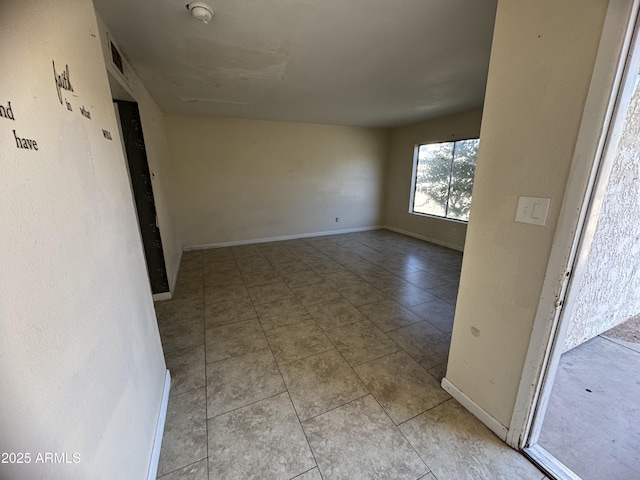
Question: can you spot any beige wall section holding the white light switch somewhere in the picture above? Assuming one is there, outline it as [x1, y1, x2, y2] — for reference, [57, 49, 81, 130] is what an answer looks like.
[446, 0, 607, 427]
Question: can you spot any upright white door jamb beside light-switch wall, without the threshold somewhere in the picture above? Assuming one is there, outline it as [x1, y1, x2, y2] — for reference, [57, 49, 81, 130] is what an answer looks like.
[506, 0, 638, 449]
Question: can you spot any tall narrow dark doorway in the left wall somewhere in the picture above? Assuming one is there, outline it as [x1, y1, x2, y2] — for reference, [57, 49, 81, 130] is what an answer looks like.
[115, 100, 169, 294]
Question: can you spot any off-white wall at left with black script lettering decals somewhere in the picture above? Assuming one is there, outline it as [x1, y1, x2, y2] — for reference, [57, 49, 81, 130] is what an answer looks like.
[0, 0, 165, 480]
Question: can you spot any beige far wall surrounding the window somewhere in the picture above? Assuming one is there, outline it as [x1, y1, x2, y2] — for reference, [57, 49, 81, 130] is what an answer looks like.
[384, 109, 482, 250]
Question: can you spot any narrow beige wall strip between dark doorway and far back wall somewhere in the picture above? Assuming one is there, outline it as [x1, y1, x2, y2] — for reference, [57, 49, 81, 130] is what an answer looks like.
[97, 14, 182, 291]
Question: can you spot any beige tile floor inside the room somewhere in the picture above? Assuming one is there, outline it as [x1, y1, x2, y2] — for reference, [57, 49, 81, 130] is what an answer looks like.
[156, 230, 545, 480]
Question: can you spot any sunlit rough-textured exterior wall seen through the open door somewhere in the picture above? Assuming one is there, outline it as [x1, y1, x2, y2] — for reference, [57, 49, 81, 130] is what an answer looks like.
[564, 76, 640, 351]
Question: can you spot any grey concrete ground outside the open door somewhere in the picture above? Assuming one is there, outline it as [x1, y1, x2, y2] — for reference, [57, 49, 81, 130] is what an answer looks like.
[538, 316, 640, 480]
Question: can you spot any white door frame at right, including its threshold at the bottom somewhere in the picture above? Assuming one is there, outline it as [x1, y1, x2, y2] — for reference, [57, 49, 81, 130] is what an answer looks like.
[506, 0, 640, 466]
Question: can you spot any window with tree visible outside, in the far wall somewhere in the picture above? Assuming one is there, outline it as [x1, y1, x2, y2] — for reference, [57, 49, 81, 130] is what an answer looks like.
[410, 138, 480, 222]
